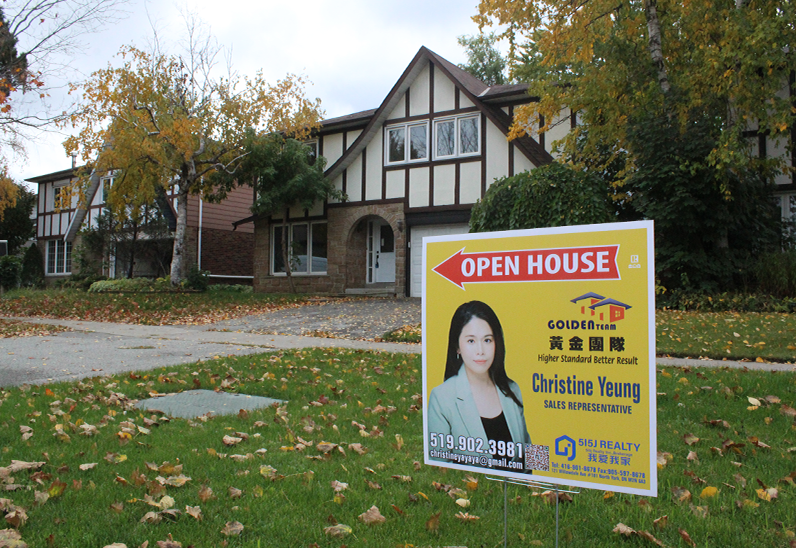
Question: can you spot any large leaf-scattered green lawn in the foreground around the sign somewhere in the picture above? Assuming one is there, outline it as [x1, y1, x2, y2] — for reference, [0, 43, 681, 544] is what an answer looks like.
[0, 349, 796, 548]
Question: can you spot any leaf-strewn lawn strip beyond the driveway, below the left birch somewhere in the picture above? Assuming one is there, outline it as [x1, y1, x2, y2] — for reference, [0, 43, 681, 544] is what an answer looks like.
[0, 289, 305, 325]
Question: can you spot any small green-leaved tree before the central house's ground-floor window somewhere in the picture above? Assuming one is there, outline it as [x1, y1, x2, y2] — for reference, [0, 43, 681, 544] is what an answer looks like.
[212, 130, 336, 293]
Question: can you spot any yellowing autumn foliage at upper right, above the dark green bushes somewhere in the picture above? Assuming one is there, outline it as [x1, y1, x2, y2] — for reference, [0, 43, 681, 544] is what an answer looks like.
[475, 0, 796, 180]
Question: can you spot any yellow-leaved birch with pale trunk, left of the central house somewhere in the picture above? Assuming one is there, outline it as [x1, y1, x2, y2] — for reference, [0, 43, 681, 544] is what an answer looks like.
[65, 26, 320, 285]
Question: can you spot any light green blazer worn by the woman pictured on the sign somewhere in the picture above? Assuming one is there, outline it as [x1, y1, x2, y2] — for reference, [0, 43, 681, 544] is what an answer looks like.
[427, 365, 531, 455]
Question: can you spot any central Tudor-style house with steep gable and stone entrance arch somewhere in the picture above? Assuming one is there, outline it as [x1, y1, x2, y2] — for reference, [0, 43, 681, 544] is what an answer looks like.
[246, 47, 575, 297]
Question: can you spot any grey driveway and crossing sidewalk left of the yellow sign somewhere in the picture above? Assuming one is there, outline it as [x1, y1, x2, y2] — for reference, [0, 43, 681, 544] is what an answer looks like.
[0, 299, 420, 387]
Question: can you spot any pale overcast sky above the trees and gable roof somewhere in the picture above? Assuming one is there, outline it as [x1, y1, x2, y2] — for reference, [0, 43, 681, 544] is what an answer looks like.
[10, 0, 498, 188]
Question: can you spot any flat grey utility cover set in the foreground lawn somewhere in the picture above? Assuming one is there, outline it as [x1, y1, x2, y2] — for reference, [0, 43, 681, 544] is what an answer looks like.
[136, 390, 284, 419]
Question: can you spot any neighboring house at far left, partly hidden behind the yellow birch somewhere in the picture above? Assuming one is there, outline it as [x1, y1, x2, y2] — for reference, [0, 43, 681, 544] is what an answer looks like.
[27, 167, 254, 283]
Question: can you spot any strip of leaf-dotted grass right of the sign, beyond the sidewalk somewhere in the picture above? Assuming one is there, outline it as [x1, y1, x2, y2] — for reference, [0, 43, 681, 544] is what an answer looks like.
[656, 310, 796, 363]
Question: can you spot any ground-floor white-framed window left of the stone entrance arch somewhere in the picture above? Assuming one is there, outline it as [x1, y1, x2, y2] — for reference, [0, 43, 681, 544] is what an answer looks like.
[271, 222, 327, 276]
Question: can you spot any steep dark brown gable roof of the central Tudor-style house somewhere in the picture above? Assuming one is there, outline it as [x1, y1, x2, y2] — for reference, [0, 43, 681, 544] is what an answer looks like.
[322, 46, 553, 179]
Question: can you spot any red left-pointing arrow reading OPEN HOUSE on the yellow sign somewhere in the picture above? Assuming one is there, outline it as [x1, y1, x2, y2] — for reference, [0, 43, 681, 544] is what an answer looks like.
[433, 245, 621, 289]
